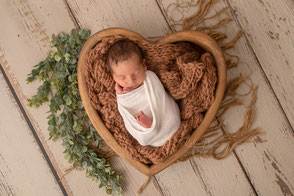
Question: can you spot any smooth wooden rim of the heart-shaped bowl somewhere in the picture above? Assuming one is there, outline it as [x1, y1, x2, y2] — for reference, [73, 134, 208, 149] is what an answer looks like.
[78, 28, 226, 176]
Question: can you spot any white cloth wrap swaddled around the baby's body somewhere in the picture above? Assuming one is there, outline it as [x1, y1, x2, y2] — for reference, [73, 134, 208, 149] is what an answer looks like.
[116, 70, 181, 147]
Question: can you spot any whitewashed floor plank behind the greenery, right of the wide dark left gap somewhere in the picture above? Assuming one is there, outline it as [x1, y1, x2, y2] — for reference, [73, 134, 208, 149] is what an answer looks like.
[0, 0, 105, 195]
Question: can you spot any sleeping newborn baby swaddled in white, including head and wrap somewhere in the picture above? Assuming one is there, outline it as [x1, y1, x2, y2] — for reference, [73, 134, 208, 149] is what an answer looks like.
[106, 40, 181, 147]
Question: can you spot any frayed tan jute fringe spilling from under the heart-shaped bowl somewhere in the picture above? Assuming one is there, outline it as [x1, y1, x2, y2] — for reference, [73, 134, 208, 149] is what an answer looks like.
[138, 0, 263, 194]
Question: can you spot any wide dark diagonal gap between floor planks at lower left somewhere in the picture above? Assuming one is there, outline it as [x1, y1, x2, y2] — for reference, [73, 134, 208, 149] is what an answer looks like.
[0, 64, 68, 196]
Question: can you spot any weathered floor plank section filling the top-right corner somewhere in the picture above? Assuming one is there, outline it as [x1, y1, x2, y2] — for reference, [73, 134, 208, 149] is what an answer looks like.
[228, 0, 294, 128]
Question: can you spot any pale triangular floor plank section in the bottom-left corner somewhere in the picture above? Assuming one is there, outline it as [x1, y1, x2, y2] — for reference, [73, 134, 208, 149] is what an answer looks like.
[0, 72, 63, 196]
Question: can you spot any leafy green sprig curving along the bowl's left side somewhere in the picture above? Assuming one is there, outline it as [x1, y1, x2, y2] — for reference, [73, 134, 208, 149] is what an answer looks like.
[27, 29, 123, 195]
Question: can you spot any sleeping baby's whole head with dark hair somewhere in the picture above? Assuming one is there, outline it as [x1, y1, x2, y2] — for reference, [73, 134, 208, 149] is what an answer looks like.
[106, 39, 147, 91]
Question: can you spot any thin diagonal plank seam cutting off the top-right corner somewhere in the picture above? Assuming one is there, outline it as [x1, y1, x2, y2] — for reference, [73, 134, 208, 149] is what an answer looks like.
[224, 0, 294, 132]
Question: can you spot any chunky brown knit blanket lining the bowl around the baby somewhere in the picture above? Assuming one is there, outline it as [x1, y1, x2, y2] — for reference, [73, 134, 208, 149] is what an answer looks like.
[84, 36, 217, 164]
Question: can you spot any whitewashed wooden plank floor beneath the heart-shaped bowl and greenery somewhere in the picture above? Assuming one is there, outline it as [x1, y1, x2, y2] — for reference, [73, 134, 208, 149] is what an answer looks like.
[0, 0, 294, 196]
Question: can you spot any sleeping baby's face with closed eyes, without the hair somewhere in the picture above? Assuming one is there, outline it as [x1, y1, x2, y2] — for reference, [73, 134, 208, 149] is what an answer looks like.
[110, 53, 147, 91]
